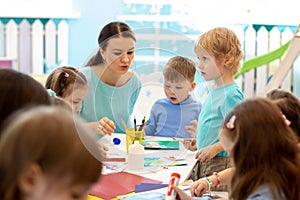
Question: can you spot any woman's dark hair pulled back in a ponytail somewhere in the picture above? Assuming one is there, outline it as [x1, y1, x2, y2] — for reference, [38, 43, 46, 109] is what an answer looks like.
[86, 22, 136, 66]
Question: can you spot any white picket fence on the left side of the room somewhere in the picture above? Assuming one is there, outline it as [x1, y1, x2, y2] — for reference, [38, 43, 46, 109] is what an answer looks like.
[0, 19, 69, 74]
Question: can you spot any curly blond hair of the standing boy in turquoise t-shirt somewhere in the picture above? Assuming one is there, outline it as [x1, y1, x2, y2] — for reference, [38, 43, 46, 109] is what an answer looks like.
[194, 27, 243, 75]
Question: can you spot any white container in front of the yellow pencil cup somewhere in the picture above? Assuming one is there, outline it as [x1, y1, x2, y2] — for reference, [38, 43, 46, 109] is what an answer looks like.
[128, 140, 145, 170]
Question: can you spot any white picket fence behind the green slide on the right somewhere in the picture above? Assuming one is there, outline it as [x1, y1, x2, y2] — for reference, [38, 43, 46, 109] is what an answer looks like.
[234, 26, 300, 98]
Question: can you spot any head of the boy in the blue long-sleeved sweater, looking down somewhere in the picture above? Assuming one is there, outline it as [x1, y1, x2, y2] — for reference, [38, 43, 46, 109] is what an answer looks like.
[163, 56, 196, 104]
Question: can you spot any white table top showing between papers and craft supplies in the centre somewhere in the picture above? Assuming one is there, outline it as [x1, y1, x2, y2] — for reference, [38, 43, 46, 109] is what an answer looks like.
[99, 133, 196, 183]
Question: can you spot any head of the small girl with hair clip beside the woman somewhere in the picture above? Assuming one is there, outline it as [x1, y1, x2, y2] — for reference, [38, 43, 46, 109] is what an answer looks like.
[45, 66, 88, 112]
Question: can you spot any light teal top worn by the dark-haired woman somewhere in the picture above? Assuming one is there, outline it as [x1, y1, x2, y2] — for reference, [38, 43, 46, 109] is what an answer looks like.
[79, 67, 142, 133]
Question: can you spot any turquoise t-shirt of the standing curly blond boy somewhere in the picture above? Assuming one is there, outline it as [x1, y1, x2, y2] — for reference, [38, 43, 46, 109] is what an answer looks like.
[196, 83, 244, 157]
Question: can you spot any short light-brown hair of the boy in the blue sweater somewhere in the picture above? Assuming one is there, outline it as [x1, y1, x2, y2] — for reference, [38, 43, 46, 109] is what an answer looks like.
[163, 56, 196, 82]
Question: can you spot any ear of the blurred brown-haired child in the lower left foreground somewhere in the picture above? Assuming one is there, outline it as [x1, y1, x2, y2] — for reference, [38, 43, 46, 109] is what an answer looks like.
[18, 163, 42, 195]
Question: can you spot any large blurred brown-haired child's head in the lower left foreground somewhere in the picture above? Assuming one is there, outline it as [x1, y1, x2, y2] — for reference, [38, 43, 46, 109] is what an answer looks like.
[0, 107, 102, 200]
